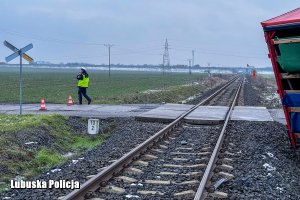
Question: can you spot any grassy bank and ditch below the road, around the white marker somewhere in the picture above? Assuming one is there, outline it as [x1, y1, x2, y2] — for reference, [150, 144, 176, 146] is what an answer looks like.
[0, 114, 114, 192]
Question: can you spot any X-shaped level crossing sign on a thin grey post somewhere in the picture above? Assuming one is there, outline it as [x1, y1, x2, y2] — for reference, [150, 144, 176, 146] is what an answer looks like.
[3, 40, 33, 115]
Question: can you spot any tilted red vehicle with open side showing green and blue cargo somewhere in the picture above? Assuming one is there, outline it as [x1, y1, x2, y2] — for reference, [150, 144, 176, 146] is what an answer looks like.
[261, 8, 300, 149]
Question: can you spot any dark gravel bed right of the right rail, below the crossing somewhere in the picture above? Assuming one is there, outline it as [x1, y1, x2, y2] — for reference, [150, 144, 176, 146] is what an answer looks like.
[219, 121, 300, 199]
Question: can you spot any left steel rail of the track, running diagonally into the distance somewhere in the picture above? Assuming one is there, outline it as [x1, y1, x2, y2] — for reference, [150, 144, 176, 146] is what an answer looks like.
[63, 76, 239, 200]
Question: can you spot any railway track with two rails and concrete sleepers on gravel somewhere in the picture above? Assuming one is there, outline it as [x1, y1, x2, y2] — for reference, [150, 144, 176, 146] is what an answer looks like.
[64, 77, 242, 199]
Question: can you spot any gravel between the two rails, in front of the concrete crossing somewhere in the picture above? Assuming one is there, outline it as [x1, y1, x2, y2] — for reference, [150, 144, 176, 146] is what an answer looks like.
[94, 125, 221, 199]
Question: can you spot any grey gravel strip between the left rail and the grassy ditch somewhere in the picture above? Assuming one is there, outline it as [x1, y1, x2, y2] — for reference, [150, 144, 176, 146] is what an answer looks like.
[0, 118, 165, 199]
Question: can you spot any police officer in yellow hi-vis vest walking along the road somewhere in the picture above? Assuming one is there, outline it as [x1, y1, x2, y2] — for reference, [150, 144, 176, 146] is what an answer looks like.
[77, 67, 92, 104]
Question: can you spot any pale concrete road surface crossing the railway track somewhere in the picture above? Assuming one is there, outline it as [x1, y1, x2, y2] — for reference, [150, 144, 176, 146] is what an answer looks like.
[0, 103, 286, 124]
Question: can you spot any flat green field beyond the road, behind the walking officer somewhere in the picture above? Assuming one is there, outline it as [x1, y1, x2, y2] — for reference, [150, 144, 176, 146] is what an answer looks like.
[0, 68, 207, 104]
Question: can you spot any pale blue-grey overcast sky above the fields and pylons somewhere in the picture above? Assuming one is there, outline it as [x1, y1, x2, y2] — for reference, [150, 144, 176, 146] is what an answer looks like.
[0, 0, 299, 67]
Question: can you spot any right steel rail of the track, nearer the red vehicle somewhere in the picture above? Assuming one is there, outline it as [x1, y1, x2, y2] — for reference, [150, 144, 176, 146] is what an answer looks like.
[194, 77, 244, 200]
